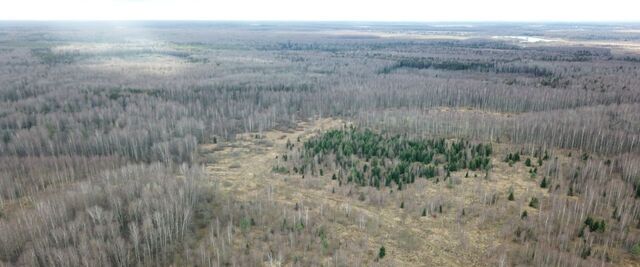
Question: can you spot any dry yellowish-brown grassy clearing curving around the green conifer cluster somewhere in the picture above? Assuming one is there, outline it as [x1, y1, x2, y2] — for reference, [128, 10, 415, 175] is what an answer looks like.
[200, 119, 546, 266]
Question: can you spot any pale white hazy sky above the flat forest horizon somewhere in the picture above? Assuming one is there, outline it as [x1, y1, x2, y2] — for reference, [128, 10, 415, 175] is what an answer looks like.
[0, 0, 640, 21]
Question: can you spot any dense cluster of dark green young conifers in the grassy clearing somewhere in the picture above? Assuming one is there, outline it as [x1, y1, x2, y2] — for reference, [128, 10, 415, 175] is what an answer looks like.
[276, 127, 491, 190]
